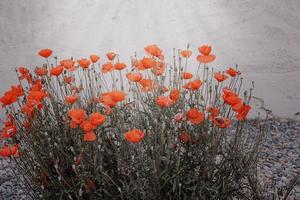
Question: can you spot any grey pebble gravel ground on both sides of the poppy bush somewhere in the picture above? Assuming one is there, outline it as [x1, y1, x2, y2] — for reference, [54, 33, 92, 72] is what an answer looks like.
[0, 119, 300, 200]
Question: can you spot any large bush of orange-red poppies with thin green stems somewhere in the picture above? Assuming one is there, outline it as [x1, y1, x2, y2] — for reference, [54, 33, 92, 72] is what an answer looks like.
[0, 45, 272, 199]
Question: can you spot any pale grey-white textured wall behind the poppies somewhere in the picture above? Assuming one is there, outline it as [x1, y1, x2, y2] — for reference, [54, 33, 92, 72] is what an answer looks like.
[0, 0, 300, 117]
